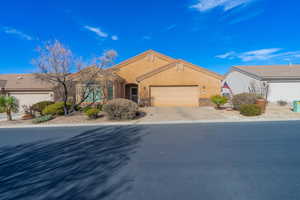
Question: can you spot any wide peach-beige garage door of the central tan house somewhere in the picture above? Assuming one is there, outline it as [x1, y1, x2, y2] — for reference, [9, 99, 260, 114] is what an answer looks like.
[151, 86, 199, 107]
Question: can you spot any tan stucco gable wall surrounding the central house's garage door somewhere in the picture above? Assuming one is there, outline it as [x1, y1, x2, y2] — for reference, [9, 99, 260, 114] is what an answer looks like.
[139, 66, 221, 98]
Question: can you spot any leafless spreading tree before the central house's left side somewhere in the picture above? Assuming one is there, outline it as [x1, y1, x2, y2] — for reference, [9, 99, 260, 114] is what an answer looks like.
[33, 40, 117, 115]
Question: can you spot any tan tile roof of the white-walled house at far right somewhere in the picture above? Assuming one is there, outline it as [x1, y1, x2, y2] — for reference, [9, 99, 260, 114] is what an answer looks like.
[233, 65, 300, 79]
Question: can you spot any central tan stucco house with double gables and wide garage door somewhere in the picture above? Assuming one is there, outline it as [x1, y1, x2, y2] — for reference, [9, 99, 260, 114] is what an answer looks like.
[109, 50, 223, 106]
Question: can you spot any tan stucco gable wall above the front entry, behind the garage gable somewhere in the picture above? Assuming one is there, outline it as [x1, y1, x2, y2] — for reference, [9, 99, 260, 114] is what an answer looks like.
[116, 56, 170, 83]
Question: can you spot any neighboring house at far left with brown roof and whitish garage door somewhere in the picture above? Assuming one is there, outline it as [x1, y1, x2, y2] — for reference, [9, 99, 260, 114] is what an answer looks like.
[0, 74, 54, 111]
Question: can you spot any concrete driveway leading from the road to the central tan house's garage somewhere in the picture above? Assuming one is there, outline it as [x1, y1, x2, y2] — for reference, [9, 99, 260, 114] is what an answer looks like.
[140, 107, 226, 122]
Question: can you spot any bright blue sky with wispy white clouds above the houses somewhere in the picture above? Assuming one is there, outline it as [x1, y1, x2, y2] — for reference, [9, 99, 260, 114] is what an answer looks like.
[0, 0, 300, 74]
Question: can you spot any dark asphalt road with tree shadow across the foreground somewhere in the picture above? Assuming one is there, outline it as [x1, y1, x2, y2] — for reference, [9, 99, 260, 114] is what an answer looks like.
[0, 122, 300, 200]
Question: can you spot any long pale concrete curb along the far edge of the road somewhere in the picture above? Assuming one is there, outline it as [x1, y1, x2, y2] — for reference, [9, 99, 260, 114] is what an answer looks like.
[0, 119, 300, 129]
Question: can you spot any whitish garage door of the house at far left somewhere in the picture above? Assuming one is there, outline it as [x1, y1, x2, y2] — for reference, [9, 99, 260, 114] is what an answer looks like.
[9, 92, 53, 112]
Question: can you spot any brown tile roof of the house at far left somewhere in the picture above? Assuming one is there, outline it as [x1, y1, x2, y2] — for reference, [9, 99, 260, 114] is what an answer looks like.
[0, 74, 52, 90]
